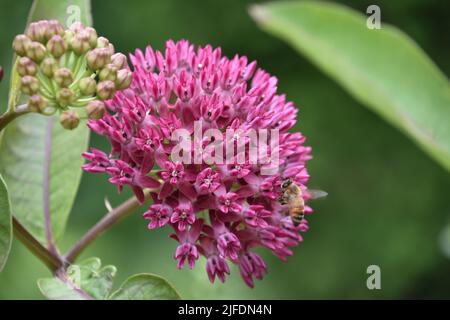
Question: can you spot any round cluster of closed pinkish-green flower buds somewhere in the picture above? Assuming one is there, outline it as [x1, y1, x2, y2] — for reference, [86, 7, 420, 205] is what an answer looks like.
[12, 20, 132, 130]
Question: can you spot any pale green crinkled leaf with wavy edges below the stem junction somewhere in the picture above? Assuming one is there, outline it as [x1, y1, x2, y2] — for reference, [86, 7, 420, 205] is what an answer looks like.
[38, 258, 116, 300]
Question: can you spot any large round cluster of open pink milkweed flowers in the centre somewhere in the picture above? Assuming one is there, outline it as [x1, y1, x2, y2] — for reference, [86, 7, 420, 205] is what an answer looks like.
[83, 40, 312, 287]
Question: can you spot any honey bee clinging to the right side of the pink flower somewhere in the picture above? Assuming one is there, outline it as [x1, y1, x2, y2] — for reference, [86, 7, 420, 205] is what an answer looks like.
[279, 179, 305, 226]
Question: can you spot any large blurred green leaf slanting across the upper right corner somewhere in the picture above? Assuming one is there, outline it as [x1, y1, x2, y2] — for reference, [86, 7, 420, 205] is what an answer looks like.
[250, 1, 450, 170]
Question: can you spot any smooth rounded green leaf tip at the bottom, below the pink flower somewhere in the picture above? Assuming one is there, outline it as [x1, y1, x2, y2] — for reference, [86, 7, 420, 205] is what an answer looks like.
[110, 273, 181, 300]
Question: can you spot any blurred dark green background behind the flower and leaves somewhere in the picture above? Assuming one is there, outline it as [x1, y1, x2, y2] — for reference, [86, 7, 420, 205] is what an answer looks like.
[0, 0, 450, 299]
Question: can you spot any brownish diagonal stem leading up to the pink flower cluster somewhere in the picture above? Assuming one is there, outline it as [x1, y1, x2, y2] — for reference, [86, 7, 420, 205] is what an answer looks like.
[64, 190, 148, 264]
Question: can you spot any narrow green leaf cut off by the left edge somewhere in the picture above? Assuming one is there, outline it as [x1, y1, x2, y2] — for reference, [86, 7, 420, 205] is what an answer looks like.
[0, 175, 12, 271]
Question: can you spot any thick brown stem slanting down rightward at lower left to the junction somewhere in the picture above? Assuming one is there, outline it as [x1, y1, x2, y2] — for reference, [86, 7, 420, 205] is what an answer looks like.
[13, 216, 63, 273]
